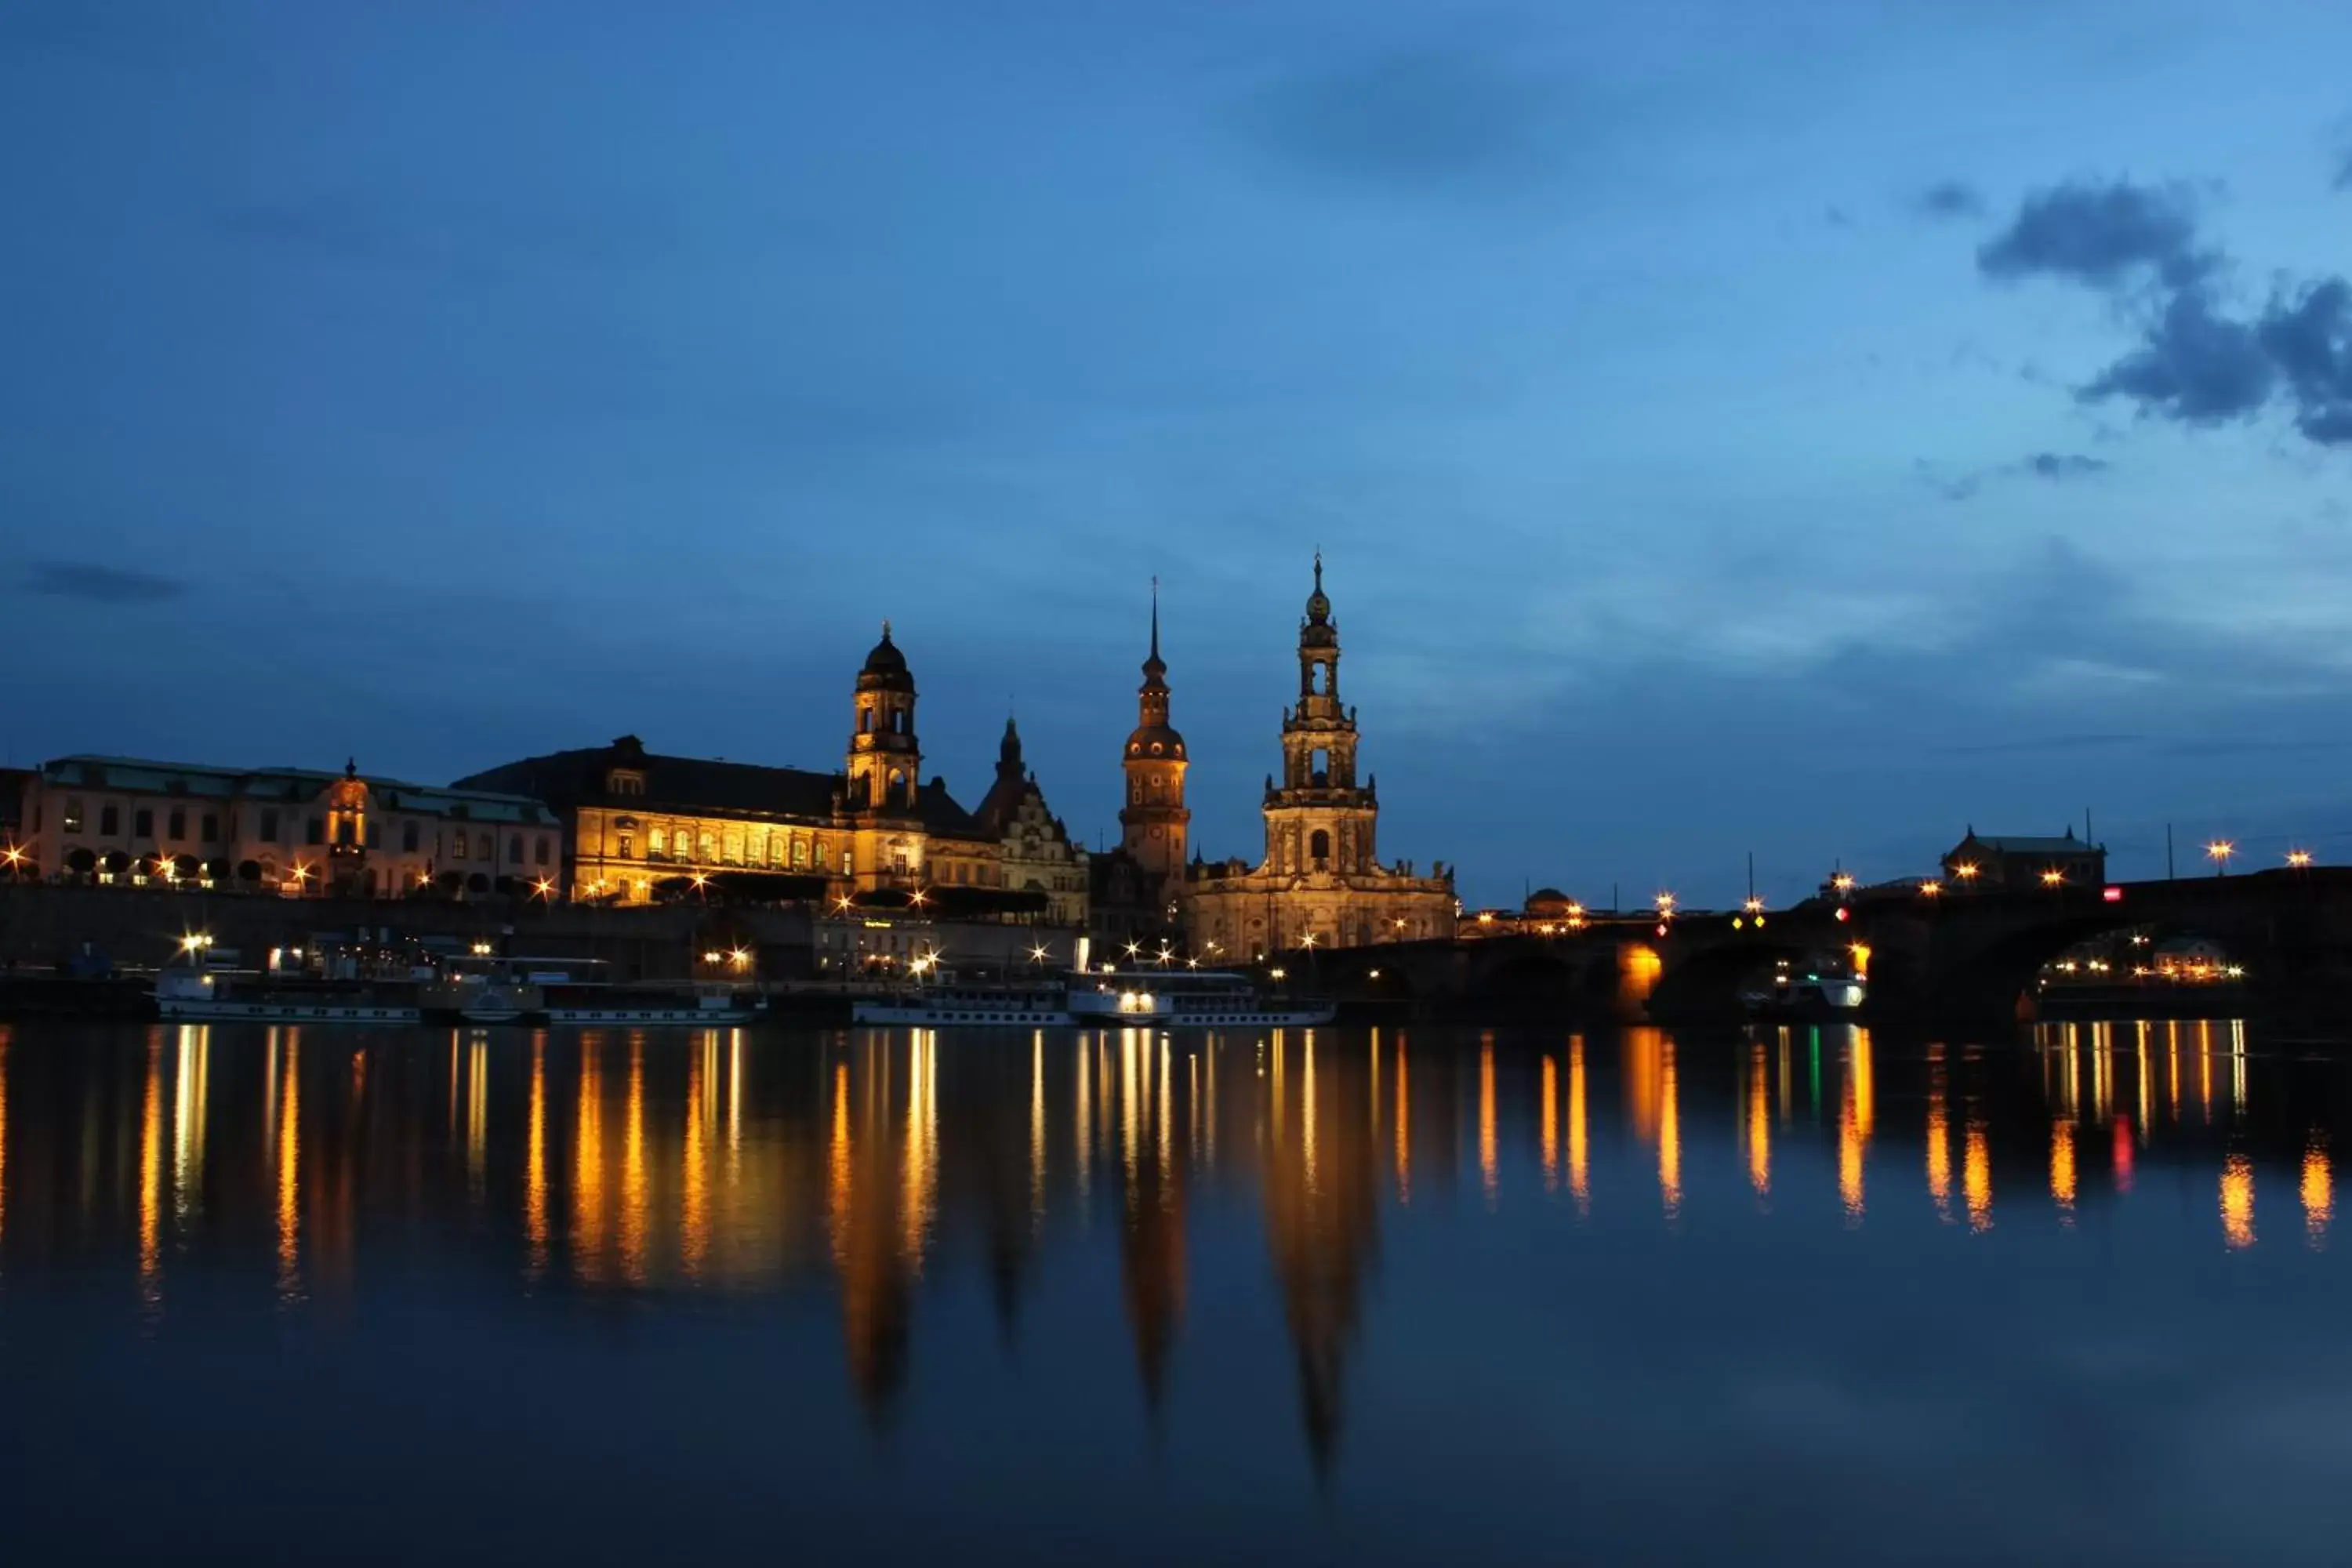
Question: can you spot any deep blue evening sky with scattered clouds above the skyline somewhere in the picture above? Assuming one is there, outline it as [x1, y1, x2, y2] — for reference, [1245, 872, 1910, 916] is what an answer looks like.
[0, 0, 2352, 900]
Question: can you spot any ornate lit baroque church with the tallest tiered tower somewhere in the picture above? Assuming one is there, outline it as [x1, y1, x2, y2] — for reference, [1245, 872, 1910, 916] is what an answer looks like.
[1195, 555, 1456, 959]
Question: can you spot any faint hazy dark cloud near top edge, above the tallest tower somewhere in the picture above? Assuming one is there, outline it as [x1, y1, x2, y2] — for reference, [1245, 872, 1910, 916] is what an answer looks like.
[1244, 47, 1562, 191]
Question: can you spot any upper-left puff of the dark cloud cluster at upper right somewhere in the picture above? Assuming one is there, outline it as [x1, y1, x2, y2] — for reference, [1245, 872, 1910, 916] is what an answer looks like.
[1976, 181, 2218, 289]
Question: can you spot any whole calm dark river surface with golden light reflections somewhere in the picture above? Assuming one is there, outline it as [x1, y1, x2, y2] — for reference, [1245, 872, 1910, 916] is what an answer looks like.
[0, 1022, 2352, 1568]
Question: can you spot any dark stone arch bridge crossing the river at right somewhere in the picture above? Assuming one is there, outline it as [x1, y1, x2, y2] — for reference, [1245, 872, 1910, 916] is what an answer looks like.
[1317, 867, 2352, 1022]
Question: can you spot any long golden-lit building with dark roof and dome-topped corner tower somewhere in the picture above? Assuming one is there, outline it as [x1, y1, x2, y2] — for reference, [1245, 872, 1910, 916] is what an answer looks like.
[459, 623, 1007, 914]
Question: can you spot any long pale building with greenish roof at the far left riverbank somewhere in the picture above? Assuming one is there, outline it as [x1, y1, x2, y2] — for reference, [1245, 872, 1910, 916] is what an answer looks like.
[0, 757, 562, 898]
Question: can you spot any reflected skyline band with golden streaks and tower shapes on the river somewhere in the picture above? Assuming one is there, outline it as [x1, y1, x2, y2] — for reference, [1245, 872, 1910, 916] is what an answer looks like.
[0, 1022, 2336, 1465]
